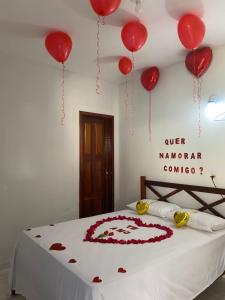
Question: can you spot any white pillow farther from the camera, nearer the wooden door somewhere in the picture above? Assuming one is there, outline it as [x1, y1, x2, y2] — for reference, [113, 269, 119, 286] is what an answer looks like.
[127, 199, 181, 218]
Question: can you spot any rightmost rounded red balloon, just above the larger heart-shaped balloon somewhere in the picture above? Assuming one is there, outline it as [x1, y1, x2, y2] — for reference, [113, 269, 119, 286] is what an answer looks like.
[178, 14, 205, 50]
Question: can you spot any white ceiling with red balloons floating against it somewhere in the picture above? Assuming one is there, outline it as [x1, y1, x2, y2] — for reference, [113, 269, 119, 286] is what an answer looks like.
[0, 0, 225, 82]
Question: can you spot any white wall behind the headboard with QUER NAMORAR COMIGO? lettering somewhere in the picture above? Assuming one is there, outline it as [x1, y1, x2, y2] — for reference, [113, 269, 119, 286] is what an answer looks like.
[120, 47, 225, 208]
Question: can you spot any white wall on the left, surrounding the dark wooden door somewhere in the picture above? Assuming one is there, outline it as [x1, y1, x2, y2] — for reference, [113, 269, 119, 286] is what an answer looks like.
[0, 54, 119, 265]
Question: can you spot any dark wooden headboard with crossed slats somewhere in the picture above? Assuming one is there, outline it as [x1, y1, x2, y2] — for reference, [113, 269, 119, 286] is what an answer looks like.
[141, 176, 225, 219]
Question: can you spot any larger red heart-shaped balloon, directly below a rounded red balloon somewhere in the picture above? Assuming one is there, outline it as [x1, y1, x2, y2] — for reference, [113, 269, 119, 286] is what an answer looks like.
[185, 47, 213, 78]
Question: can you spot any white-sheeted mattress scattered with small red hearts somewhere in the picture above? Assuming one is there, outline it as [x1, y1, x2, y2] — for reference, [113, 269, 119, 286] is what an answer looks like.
[11, 210, 225, 300]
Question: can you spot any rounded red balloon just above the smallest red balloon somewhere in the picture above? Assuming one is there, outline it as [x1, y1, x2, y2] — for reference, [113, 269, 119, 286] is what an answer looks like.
[121, 22, 148, 52]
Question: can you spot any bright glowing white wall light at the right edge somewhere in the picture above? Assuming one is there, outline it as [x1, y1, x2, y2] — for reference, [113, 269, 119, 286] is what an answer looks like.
[205, 96, 225, 121]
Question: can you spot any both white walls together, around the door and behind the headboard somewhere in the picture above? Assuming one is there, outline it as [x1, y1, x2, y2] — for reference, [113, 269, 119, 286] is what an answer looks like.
[0, 47, 225, 265]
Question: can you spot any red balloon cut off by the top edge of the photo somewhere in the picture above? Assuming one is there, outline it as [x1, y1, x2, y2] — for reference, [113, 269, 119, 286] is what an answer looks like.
[90, 0, 121, 17]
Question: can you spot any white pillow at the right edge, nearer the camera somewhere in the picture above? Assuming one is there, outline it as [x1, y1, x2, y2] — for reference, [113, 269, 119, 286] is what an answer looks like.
[169, 208, 225, 232]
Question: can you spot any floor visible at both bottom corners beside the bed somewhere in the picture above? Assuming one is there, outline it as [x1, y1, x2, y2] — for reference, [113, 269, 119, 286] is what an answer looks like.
[0, 270, 225, 300]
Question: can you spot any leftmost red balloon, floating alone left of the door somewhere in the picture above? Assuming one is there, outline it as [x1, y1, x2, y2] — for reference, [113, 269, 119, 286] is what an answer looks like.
[45, 31, 73, 63]
